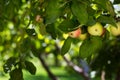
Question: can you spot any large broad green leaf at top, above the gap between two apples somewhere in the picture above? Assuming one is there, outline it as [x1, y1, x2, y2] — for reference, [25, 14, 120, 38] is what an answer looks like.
[71, 1, 88, 24]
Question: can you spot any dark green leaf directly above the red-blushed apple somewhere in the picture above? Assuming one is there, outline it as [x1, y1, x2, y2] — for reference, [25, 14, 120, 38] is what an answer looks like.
[58, 20, 78, 33]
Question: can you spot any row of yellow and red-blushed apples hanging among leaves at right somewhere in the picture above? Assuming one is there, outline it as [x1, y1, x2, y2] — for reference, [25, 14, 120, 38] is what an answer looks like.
[68, 22, 120, 40]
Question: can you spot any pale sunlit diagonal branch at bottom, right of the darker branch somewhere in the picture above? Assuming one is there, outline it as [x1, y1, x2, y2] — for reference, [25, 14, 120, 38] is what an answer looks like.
[63, 56, 90, 80]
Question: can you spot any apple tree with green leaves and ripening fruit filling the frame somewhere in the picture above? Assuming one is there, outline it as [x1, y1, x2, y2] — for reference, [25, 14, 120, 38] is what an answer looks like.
[0, 0, 120, 80]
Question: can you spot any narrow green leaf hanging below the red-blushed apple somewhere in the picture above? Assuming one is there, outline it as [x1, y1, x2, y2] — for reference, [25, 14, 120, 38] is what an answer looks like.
[61, 37, 72, 55]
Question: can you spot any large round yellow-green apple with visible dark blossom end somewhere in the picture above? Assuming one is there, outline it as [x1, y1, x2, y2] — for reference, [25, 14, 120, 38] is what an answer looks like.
[87, 22, 104, 36]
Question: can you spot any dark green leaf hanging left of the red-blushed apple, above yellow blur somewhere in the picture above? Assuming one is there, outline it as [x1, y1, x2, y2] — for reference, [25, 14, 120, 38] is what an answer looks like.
[46, 24, 57, 39]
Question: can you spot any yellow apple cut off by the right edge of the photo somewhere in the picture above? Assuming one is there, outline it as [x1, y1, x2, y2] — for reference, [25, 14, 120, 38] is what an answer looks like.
[110, 22, 120, 36]
